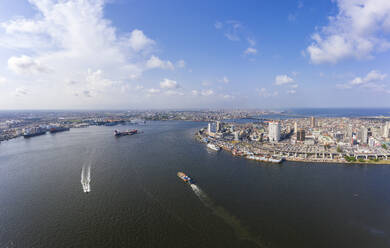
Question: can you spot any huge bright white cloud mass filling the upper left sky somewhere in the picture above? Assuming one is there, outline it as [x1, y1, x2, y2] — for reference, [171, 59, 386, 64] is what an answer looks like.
[0, 0, 174, 107]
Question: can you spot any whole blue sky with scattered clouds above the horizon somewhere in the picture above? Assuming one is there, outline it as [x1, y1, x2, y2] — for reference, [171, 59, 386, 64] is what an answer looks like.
[0, 0, 390, 110]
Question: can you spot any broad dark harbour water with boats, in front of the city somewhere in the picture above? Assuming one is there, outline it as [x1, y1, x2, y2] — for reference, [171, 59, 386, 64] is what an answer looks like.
[0, 122, 390, 248]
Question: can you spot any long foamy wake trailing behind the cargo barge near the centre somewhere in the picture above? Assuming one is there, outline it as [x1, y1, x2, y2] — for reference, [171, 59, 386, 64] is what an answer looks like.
[191, 184, 267, 247]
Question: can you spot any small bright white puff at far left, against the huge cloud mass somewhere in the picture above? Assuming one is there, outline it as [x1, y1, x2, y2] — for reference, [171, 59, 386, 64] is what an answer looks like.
[8, 55, 49, 74]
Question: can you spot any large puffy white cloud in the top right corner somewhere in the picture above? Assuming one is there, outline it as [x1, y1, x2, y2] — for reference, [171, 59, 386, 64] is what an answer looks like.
[307, 0, 390, 64]
